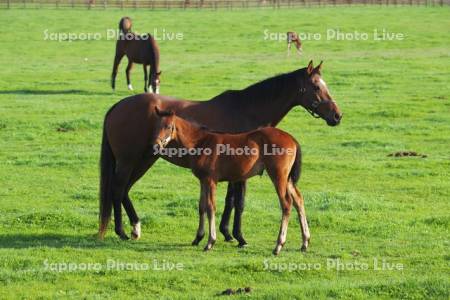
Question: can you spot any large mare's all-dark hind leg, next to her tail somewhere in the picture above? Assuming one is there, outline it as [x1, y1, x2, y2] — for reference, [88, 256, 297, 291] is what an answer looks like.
[112, 162, 133, 240]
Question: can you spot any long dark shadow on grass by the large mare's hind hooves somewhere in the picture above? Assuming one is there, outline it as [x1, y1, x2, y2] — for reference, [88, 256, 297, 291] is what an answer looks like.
[0, 233, 192, 252]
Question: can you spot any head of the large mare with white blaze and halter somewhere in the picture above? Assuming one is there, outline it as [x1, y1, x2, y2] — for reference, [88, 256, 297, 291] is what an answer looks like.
[299, 61, 342, 126]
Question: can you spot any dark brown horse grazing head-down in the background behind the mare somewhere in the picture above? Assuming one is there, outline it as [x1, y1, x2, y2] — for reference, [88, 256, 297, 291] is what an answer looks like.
[111, 17, 161, 94]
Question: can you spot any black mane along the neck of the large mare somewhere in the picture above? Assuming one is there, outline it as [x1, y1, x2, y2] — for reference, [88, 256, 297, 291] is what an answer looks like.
[211, 68, 306, 105]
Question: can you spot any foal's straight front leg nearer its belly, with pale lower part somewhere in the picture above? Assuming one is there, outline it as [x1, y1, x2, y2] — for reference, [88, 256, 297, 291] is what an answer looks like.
[201, 179, 216, 251]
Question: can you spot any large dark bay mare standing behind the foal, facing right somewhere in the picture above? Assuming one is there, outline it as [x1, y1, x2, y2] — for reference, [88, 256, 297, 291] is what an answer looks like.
[99, 61, 342, 246]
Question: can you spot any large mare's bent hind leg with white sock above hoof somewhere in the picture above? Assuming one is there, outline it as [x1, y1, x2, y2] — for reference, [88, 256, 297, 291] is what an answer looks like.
[122, 156, 158, 240]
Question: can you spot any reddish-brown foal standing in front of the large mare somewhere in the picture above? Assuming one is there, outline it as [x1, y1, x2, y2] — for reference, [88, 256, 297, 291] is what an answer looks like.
[154, 106, 310, 255]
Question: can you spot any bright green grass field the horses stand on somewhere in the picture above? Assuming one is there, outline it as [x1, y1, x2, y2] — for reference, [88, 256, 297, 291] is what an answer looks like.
[0, 6, 450, 299]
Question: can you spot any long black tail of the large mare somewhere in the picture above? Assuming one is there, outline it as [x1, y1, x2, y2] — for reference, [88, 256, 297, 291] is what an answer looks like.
[99, 108, 116, 238]
